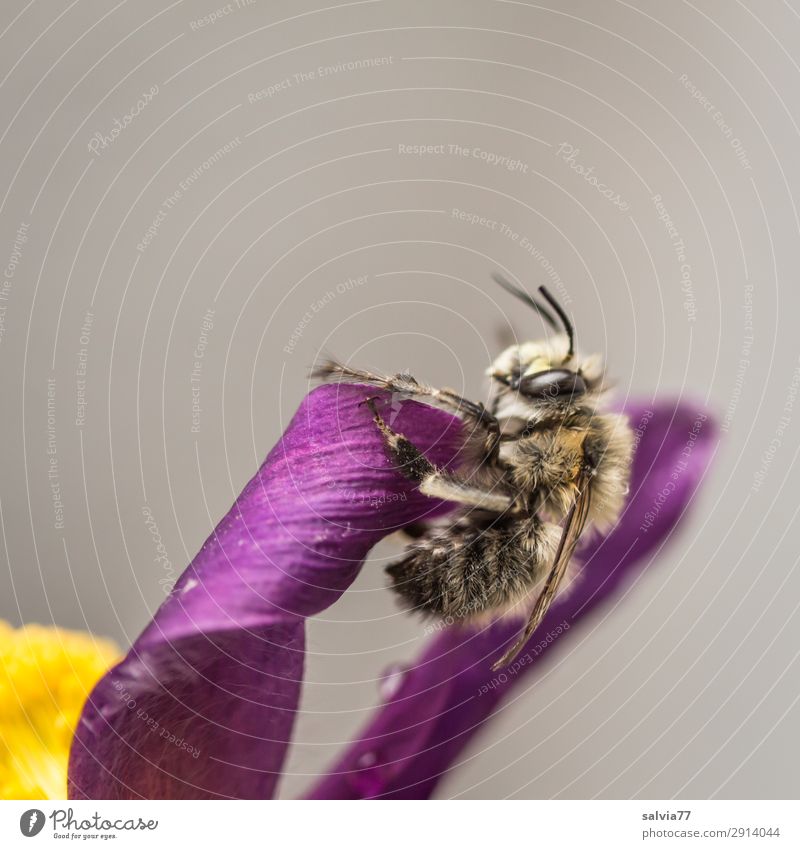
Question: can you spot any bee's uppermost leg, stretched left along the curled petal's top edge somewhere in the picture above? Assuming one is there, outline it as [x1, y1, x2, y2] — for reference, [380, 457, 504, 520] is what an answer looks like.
[313, 362, 500, 459]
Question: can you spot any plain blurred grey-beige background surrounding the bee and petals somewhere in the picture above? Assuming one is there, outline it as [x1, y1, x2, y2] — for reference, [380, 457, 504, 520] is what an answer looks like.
[0, 0, 800, 798]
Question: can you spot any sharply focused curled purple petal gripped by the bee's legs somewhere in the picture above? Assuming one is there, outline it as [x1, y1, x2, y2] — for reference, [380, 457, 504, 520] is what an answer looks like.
[69, 386, 462, 799]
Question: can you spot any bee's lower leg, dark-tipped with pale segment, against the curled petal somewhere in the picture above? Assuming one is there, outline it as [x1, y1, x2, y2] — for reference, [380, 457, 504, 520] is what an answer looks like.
[364, 398, 513, 513]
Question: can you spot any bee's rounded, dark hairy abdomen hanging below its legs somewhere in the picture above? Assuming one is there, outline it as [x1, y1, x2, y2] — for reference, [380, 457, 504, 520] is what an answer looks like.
[386, 516, 559, 619]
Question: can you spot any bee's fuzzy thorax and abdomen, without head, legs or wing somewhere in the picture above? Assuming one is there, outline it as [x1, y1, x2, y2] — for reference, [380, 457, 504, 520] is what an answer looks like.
[387, 404, 630, 620]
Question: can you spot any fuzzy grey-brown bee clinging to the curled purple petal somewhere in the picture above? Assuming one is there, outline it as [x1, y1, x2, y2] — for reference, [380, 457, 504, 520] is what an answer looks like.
[315, 275, 633, 669]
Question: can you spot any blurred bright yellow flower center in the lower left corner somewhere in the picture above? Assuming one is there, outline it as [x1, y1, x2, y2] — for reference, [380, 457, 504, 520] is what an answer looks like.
[0, 620, 119, 799]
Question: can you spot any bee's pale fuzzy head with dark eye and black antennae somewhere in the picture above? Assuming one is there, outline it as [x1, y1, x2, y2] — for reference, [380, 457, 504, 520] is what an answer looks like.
[487, 276, 603, 408]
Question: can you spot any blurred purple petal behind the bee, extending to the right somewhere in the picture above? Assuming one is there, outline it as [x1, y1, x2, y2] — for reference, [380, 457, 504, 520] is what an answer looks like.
[310, 402, 716, 799]
